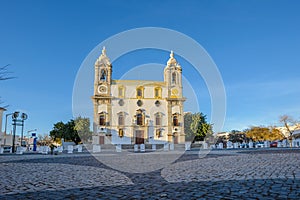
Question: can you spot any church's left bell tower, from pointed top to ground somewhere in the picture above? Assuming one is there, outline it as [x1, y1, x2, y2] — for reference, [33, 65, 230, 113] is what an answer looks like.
[92, 47, 112, 144]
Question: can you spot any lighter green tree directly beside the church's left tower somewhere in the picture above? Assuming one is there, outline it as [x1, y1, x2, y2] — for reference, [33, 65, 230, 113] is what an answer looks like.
[74, 117, 93, 142]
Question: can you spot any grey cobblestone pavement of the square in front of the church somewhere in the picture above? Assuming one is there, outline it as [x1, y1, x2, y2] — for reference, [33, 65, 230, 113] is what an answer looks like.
[0, 149, 300, 199]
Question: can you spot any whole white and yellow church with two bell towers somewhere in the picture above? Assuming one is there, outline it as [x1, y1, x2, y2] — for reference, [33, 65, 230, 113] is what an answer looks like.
[92, 48, 185, 144]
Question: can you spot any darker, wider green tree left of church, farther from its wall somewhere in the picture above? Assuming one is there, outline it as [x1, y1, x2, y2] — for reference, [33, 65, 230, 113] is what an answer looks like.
[50, 120, 81, 144]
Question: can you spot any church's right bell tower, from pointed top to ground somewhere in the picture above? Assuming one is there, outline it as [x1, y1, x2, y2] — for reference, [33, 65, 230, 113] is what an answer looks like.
[164, 51, 185, 144]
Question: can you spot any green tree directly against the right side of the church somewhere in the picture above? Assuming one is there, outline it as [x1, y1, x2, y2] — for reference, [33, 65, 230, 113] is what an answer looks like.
[190, 113, 212, 142]
